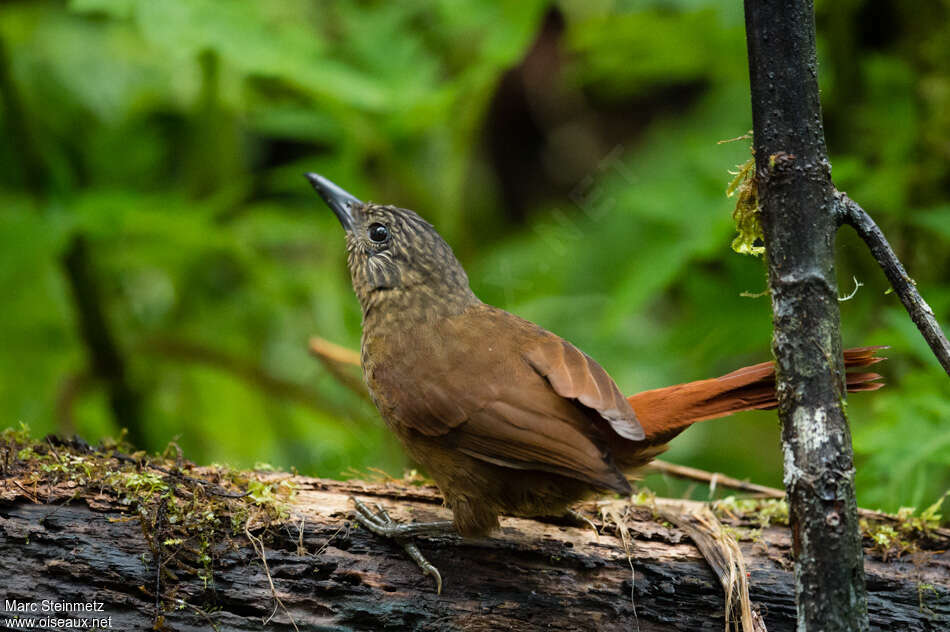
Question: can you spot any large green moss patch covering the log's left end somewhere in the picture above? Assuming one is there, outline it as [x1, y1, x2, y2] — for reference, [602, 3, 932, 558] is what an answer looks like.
[0, 425, 295, 624]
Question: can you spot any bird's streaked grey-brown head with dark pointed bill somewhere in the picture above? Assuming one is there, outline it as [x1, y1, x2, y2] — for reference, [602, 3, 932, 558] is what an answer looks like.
[306, 173, 477, 314]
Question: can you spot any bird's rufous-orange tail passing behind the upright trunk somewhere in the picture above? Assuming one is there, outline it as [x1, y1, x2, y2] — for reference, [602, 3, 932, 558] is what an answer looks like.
[627, 347, 886, 444]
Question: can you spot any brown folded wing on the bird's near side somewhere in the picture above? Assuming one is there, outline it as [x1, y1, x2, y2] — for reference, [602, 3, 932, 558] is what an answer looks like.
[384, 310, 643, 493]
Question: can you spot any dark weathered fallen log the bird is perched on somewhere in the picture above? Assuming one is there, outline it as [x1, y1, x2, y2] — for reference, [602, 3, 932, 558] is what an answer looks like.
[0, 468, 950, 632]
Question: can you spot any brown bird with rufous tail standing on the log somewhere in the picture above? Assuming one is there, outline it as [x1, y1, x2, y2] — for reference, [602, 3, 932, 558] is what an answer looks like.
[307, 173, 881, 589]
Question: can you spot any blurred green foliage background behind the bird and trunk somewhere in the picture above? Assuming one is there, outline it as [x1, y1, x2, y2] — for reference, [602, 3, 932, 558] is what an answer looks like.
[0, 0, 950, 509]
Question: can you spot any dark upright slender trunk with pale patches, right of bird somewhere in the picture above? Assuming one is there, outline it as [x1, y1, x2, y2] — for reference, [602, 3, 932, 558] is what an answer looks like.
[745, 0, 868, 632]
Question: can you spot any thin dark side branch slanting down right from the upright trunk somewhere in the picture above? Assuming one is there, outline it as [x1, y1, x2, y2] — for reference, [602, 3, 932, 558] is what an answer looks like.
[835, 191, 950, 375]
